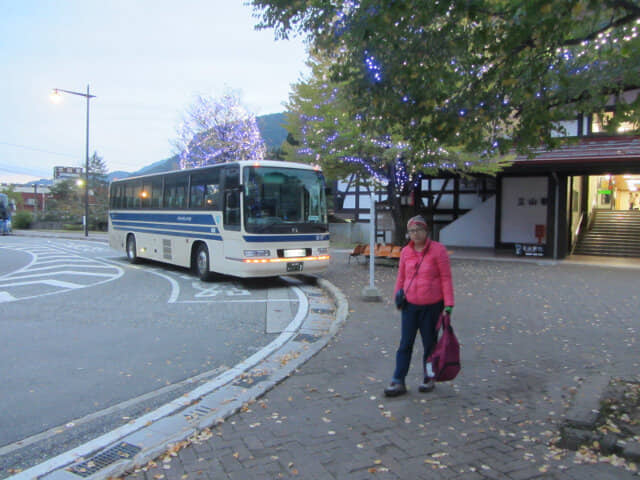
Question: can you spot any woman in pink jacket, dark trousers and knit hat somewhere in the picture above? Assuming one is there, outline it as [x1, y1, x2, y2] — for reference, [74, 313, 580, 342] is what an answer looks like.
[384, 215, 454, 397]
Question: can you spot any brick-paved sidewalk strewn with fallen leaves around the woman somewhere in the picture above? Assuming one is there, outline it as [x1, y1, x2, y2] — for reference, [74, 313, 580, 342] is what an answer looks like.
[119, 252, 640, 480]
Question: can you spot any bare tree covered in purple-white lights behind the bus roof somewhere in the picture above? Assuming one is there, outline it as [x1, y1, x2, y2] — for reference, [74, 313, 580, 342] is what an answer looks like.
[176, 93, 266, 168]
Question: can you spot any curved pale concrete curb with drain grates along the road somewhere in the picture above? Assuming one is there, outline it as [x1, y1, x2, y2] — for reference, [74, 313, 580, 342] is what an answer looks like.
[7, 277, 349, 480]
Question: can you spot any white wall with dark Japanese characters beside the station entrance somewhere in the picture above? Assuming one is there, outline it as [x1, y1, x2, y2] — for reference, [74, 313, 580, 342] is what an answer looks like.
[500, 177, 549, 244]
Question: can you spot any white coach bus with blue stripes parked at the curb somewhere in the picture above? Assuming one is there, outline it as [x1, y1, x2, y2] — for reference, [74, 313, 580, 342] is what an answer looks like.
[109, 160, 330, 280]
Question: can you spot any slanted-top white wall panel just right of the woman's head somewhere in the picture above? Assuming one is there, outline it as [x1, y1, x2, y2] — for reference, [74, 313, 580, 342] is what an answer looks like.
[440, 195, 496, 248]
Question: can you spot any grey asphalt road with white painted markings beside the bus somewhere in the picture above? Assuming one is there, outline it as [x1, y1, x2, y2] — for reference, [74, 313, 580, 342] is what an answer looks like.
[0, 237, 298, 468]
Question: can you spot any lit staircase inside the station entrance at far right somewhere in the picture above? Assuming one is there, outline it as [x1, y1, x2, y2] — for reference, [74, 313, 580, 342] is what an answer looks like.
[573, 210, 640, 257]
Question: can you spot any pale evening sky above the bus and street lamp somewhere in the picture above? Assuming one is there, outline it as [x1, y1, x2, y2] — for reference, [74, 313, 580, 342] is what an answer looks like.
[0, 0, 308, 183]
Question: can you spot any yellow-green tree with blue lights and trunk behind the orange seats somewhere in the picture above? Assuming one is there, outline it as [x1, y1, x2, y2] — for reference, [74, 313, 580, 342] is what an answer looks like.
[284, 53, 510, 243]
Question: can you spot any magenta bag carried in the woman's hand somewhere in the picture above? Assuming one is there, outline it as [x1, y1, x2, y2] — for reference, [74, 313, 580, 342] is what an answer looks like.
[425, 314, 462, 382]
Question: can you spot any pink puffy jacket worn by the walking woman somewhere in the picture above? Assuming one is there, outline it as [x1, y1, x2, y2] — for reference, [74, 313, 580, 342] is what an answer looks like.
[393, 240, 454, 307]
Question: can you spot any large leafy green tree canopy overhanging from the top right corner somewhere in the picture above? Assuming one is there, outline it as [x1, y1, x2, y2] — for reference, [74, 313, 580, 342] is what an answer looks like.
[251, 0, 640, 163]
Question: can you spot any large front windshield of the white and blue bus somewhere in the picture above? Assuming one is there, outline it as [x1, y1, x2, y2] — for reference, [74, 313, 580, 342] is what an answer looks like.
[242, 166, 327, 233]
